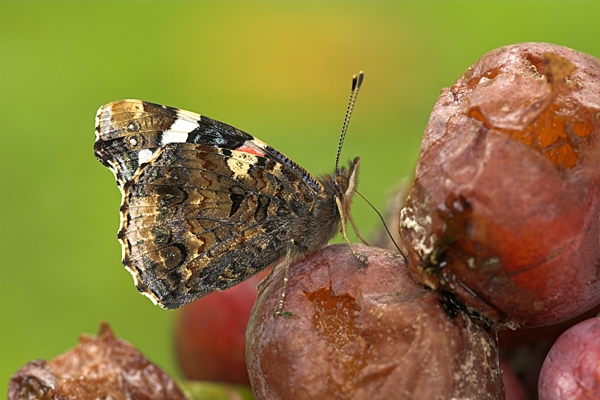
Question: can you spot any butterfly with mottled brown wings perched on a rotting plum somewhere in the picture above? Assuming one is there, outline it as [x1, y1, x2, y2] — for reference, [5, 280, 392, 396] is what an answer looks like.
[94, 72, 366, 312]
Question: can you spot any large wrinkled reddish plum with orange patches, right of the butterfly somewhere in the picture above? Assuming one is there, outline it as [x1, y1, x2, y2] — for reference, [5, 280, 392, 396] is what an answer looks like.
[400, 43, 600, 327]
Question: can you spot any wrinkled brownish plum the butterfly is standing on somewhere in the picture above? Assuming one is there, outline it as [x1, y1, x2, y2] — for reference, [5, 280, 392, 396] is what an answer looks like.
[246, 244, 504, 400]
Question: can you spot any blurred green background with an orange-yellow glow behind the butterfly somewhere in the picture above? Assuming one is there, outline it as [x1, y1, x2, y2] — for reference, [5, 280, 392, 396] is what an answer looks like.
[0, 0, 600, 396]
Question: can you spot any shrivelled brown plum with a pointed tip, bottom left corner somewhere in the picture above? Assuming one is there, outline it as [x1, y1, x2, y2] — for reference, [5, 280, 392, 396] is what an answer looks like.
[8, 323, 185, 400]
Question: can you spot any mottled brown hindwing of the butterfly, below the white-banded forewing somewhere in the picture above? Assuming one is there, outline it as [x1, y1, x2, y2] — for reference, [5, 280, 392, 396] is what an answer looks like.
[119, 143, 316, 308]
